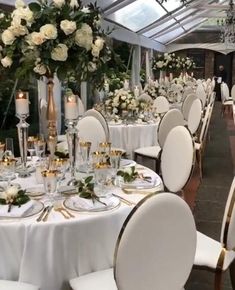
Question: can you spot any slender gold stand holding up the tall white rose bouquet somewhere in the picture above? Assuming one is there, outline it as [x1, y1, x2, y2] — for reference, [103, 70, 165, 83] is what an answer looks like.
[47, 77, 57, 159]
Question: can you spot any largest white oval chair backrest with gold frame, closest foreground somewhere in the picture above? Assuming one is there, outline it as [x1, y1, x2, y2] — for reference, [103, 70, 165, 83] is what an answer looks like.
[114, 193, 196, 290]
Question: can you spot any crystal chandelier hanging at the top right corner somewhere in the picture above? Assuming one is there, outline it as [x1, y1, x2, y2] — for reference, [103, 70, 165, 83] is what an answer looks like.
[217, 0, 235, 44]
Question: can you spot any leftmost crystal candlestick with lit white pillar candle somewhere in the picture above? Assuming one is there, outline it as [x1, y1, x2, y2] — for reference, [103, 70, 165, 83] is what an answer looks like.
[15, 91, 30, 177]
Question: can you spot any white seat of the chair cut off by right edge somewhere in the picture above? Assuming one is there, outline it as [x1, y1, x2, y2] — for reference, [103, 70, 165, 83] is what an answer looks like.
[194, 232, 235, 271]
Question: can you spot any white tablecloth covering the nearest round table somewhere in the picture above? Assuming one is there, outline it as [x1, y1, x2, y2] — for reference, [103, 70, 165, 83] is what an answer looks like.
[0, 166, 162, 290]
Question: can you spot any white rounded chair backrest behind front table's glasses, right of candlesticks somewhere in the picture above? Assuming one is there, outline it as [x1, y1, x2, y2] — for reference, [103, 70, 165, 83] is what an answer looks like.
[77, 116, 108, 151]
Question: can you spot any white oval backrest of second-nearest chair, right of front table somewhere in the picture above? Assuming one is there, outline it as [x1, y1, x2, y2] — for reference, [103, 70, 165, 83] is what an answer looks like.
[161, 126, 195, 192]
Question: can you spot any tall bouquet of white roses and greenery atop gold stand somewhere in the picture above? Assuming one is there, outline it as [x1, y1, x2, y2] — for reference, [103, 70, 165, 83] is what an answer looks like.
[0, 0, 111, 81]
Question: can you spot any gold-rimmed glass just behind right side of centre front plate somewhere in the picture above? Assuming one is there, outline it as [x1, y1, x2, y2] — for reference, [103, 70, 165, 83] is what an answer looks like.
[94, 162, 113, 197]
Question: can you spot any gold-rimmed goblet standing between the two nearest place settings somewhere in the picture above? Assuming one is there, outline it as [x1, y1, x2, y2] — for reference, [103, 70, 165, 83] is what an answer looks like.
[41, 169, 58, 203]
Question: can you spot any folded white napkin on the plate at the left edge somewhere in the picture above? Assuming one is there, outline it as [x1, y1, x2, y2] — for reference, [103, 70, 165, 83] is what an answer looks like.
[0, 200, 34, 217]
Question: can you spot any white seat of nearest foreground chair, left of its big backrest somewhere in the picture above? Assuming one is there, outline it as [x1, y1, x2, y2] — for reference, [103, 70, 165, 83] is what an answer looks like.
[69, 268, 117, 290]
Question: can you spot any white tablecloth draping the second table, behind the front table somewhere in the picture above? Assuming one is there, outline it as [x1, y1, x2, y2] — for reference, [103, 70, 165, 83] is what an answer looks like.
[109, 121, 159, 158]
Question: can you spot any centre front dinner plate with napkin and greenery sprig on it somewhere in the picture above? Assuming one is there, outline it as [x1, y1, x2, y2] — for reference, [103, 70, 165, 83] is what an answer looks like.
[63, 196, 120, 213]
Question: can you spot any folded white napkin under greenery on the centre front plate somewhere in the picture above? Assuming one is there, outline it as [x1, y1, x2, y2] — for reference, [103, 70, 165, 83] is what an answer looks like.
[71, 196, 116, 210]
